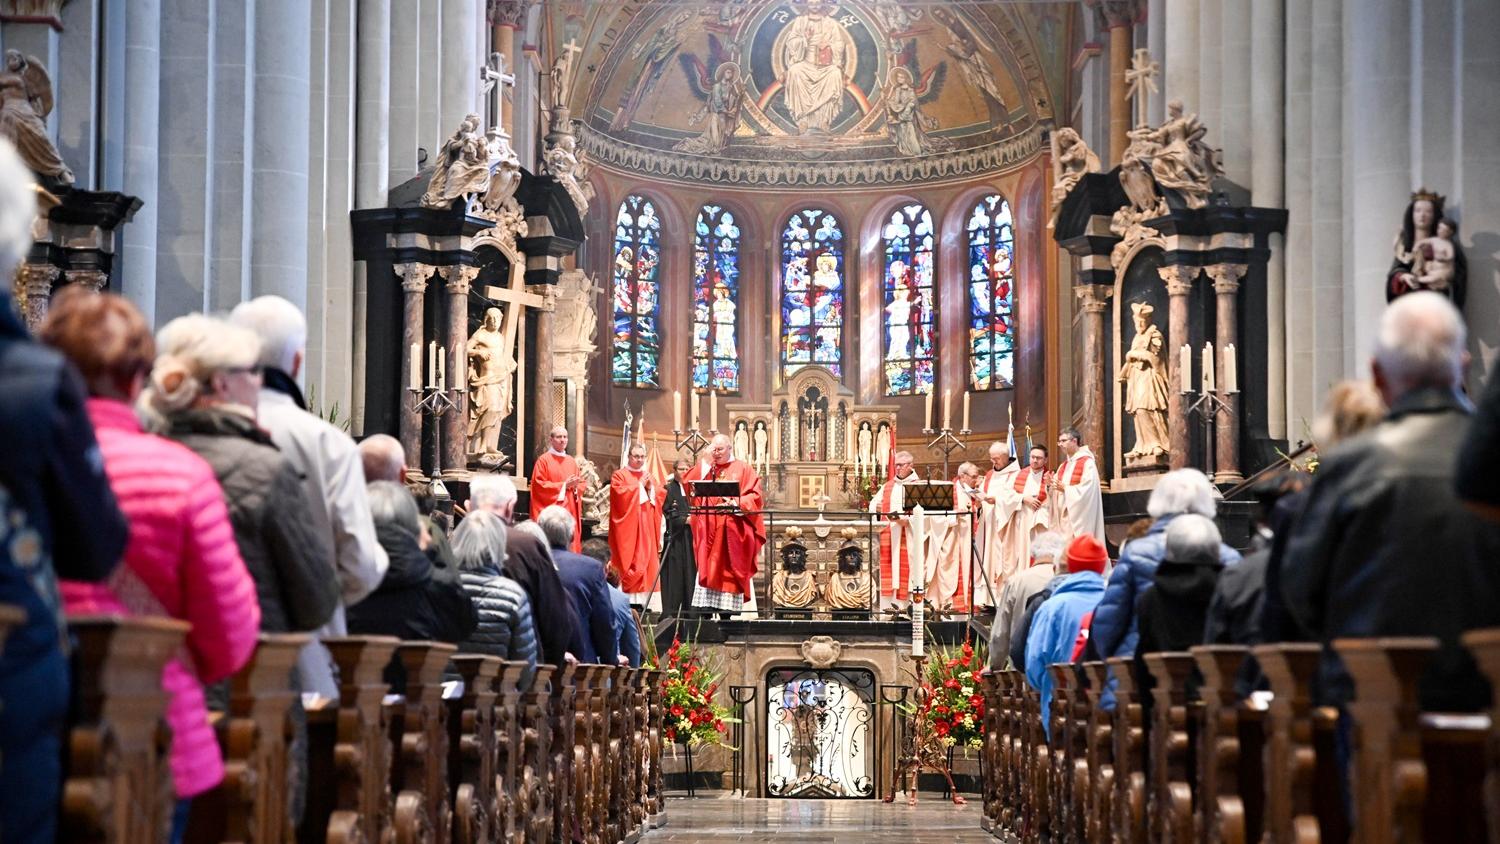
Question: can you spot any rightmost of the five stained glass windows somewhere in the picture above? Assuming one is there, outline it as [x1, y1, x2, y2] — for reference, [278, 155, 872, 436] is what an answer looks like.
[966, 193, 1016, 390]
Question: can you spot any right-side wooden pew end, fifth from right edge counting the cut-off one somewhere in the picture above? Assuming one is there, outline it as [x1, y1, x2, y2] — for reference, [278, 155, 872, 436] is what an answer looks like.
[1145, 652, 1193, 844]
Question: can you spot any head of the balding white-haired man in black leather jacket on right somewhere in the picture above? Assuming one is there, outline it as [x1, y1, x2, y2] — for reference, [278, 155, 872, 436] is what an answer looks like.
[1376, 291, 1467, 394]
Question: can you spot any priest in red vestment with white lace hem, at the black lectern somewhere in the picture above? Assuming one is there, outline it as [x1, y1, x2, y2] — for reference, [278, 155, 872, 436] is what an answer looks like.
[692, 433, 765, 613]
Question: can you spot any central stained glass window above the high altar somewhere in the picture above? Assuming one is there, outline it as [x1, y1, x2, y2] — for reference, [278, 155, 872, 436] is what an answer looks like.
[782, 208, 845, 375]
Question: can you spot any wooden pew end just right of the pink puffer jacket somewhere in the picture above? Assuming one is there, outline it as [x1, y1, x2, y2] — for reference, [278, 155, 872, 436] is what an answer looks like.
[185, 633, 312, 844]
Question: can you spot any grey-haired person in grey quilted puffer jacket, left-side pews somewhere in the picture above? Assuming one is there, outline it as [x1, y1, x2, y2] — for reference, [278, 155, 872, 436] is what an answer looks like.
[453, 510, 537, 682]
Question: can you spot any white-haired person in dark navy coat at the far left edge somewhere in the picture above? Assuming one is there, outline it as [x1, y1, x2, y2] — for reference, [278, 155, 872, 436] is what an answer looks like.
[0, 155, 129, 841]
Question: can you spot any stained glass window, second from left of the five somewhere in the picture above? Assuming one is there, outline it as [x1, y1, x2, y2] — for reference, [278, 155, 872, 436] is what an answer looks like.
[693, 205, 740, 393]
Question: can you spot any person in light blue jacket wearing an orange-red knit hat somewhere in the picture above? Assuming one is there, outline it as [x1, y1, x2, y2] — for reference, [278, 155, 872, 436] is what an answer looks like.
[1026, 534, 1110, 741]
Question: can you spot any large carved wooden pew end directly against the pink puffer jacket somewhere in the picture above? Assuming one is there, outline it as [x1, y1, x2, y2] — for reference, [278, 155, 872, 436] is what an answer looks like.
[59, 616, 188, 844]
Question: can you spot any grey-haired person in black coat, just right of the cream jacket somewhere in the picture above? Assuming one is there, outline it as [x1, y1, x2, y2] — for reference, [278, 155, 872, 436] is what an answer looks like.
[350, 481, 479, 643]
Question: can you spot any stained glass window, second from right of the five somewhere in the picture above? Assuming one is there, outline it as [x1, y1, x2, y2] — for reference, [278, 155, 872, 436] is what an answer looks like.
[881, 205, 936, 396]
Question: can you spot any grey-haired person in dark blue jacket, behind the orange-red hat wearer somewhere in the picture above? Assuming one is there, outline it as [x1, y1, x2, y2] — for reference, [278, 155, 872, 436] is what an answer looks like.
[1094, 469, 1239, 711]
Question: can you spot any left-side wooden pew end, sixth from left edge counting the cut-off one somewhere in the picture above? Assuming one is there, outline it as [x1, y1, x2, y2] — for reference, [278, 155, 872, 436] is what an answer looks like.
[449, 654, 509, 844]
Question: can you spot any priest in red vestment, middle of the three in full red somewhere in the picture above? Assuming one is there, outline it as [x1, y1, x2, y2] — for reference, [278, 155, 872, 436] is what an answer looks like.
[609, 442, 666, 606]
